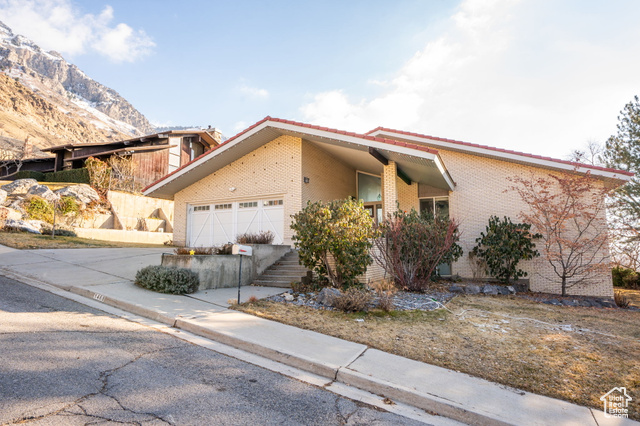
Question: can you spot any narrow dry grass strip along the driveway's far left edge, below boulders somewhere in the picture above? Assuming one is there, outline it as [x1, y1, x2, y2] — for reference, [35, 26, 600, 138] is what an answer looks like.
[0, 232, 165, 250]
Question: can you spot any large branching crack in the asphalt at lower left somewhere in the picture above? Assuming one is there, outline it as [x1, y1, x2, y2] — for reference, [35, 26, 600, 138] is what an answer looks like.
[0, 346, 181, 426]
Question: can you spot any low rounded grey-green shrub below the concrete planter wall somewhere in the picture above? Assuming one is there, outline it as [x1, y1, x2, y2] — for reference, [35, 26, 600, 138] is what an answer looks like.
[135, 265, 199, 294]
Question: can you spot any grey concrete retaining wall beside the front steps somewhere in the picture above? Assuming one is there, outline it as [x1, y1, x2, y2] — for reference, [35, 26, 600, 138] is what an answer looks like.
[159, 245, 291, 290]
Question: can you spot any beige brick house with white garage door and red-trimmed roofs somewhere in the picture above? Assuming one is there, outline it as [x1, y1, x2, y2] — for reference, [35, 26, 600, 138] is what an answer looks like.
[144, 117, 633, 297]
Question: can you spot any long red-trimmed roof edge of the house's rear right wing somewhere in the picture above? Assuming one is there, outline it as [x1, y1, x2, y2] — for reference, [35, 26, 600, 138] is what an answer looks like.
[366, 127, 634, 184]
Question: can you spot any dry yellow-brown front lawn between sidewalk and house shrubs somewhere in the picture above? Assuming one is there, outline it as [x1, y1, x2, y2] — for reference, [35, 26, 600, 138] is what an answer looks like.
[237, 292, 640, 420]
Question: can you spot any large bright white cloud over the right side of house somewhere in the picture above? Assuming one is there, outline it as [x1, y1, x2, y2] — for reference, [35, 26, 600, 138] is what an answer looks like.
[300, 0, 640, 157]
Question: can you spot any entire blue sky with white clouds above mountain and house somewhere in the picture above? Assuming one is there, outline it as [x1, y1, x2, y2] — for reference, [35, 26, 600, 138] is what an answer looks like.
[0, 0, 640, 158]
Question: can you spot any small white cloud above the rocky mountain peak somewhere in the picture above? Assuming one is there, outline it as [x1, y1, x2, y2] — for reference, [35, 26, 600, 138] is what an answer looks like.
[0, 0, 155, 63]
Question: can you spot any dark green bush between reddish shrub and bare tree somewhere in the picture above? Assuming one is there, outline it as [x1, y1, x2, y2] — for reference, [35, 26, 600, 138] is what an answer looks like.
[473, 216, 541, 283]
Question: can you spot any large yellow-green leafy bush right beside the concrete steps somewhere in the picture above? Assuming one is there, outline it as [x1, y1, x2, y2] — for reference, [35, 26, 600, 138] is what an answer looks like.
[291, 198, 376, 288]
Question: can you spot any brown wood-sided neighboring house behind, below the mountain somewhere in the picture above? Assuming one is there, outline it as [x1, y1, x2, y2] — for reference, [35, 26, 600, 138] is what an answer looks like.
[43, 129, 221, 186]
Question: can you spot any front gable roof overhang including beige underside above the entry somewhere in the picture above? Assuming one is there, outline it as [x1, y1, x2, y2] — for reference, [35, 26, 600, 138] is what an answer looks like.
[144, 117, 455, 199]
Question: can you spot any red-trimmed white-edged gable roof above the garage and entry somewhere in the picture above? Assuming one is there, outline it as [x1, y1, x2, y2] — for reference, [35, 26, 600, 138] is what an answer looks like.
[144, 116, 455, 198]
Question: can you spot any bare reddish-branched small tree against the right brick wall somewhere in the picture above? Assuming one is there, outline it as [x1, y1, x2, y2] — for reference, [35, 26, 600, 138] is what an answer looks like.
[510, 174, 610, 296]
